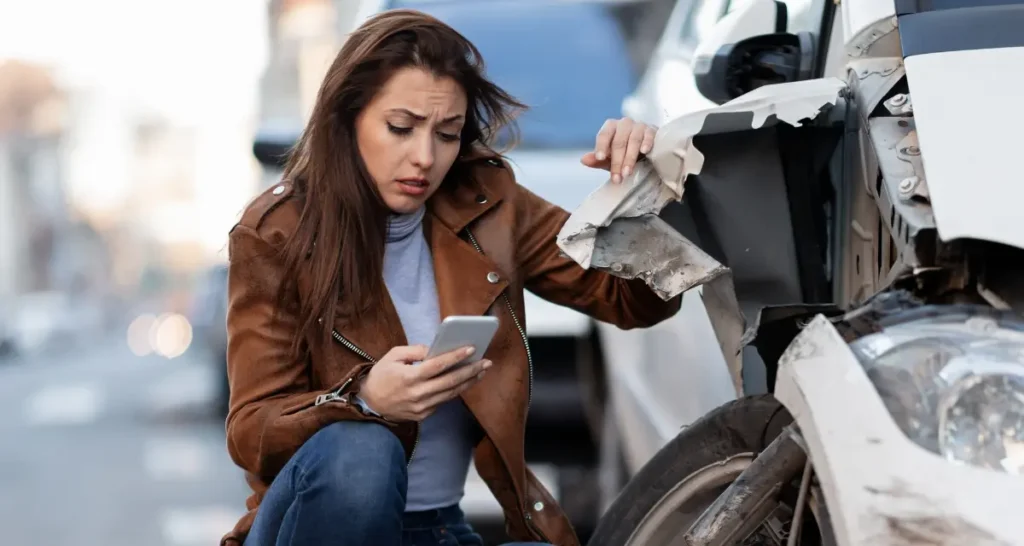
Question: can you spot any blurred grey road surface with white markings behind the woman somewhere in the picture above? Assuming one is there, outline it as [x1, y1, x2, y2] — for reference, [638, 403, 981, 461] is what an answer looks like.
[0, 337, 554, 546]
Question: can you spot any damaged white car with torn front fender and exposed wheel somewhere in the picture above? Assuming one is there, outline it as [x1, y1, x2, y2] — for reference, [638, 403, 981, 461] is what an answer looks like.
[559, 0, 1024, 546]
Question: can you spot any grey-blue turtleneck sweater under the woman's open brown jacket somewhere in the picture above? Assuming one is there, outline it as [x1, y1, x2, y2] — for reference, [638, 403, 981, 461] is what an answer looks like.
[360, 208, 473, 512]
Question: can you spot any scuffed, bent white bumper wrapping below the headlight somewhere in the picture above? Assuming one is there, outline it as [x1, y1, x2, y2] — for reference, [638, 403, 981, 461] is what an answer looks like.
[775, 316, 1024, 546]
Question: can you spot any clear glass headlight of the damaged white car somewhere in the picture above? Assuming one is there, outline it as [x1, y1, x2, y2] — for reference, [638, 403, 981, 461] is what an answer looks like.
[850, 312, 1024, 475]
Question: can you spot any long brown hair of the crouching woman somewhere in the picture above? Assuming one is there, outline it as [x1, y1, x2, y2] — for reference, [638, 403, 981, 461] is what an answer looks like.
[282, 9, 525, 358]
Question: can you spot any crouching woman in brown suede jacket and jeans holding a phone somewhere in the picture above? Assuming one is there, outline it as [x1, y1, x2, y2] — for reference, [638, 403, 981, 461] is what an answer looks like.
[223, 10, 679, 546]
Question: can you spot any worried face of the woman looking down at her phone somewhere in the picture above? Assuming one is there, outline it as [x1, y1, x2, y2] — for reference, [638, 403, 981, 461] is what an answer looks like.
[355, 68, 467, 214]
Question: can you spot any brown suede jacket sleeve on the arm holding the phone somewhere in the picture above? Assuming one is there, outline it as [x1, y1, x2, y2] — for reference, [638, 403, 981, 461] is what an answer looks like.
[227, 225, 370, 478]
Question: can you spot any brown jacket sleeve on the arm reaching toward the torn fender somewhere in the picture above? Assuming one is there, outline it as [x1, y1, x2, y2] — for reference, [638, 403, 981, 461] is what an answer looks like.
[513, 184, 682, 330]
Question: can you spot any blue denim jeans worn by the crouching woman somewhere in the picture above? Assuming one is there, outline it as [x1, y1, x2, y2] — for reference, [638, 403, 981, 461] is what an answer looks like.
[245, 421, 541, 546]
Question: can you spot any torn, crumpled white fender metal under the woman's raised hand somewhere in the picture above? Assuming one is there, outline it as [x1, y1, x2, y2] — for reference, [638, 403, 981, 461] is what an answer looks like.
[557, 78, 846, 393]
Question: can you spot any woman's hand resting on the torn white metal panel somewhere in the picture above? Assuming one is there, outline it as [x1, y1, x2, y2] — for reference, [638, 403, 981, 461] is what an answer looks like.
[580, 118, 657, 183]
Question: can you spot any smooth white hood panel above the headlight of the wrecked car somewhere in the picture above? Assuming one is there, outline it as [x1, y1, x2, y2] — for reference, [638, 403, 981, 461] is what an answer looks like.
[904, 47, 1024, 248]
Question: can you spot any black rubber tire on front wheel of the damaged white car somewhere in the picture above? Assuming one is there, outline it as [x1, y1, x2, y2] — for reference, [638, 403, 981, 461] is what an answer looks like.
[587, 394, 793, 546]
